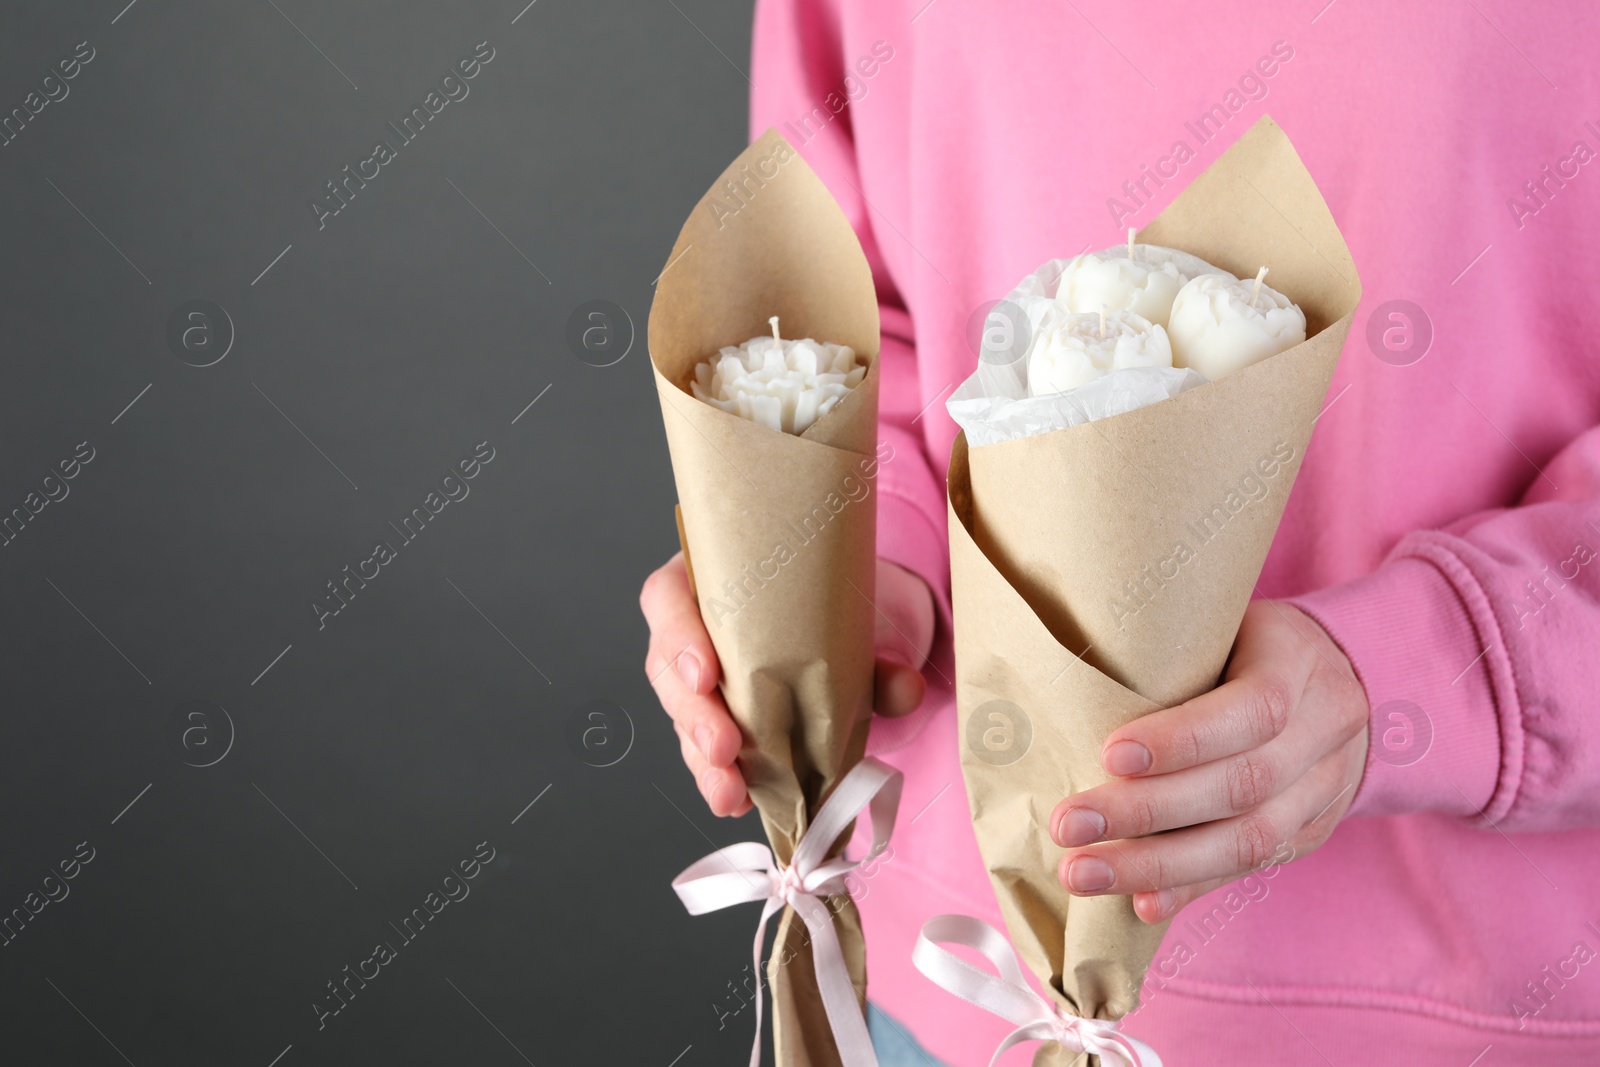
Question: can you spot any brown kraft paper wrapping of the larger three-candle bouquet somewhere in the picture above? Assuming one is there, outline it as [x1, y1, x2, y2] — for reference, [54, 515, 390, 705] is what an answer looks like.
[949, 118, 1362, 1067]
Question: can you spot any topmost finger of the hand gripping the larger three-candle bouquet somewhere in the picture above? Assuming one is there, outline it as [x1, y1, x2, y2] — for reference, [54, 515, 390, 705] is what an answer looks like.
[1101, 613, 1312, 777]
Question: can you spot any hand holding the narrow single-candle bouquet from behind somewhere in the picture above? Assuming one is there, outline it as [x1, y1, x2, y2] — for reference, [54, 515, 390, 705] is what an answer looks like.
[638, 552, 934, 816]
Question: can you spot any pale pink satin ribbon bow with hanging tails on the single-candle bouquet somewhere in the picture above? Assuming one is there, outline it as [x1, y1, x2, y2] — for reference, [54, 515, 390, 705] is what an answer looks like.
[672, 757, 902, 1067]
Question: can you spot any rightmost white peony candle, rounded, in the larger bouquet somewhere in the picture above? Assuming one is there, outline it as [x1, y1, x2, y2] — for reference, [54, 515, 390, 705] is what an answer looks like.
[1166, 267, 1306, 381]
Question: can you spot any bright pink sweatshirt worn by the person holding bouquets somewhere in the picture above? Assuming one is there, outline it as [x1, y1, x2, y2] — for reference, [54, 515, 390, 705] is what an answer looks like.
[745, 0, 1600, 1067]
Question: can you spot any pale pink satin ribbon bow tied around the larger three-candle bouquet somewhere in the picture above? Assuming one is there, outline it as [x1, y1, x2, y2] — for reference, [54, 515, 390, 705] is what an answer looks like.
[910, 915, 1162, 1067]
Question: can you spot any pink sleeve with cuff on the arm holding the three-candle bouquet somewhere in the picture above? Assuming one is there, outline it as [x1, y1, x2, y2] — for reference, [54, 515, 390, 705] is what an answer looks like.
[1290, 427, 1600, 830]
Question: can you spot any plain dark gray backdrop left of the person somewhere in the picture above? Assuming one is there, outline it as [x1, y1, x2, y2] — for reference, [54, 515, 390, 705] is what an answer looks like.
[0, 0, 760, 1067]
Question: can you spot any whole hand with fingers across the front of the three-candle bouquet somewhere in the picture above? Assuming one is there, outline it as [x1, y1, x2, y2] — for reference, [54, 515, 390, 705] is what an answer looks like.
[1050, 600, 1368, 923]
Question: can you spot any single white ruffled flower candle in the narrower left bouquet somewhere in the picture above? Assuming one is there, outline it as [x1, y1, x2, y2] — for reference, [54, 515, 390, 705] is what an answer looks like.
[690, 315, 867, 434]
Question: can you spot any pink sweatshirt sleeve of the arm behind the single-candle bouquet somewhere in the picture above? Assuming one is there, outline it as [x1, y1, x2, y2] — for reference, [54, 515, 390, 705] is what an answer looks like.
[750, 0, 950, 752]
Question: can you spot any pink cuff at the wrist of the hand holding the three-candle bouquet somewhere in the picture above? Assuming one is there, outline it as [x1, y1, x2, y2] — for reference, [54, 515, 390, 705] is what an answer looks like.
[1286, 557, 1501, 817]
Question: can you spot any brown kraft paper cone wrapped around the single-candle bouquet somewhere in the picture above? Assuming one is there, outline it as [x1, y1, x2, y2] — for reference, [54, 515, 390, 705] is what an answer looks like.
[650, 130, 878, 1067]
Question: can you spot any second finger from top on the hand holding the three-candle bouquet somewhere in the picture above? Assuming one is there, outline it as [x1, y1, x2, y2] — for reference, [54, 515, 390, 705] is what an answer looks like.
[1050, 742, 1317, 848]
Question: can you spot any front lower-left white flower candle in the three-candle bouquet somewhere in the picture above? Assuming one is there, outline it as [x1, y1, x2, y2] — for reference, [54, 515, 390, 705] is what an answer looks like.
[1027, 310, 1173, 397]
